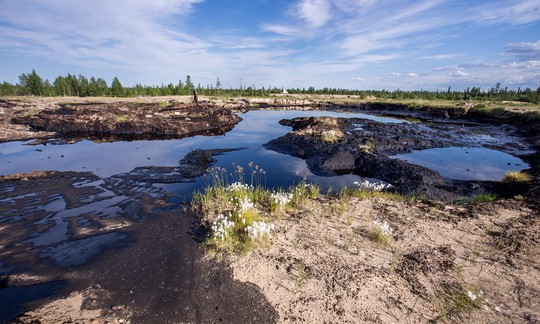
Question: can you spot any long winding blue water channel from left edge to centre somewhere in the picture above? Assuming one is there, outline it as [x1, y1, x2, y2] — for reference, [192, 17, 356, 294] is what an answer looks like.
[0, 111, 396, 194]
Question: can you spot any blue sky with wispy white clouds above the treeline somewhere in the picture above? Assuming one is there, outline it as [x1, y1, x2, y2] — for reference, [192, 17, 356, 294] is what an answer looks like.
[0, 0, 540, 90]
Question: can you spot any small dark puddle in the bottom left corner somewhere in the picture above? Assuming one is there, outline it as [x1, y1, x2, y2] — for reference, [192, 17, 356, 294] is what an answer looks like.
[0, 281, 64, 323]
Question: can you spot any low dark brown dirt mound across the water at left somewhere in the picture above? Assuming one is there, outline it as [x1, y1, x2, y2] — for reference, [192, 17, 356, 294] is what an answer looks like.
[7, 102, 241, 141]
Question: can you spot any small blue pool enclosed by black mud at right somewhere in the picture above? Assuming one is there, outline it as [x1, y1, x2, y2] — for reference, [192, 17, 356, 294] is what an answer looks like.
[390, 147, 529, 181]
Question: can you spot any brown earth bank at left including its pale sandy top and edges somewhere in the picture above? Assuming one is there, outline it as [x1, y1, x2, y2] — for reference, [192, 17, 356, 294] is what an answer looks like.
[0, 95, 242, 141]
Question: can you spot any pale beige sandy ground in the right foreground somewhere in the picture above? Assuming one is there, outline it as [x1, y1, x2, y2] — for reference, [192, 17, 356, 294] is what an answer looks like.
[230, 198, 540, 323]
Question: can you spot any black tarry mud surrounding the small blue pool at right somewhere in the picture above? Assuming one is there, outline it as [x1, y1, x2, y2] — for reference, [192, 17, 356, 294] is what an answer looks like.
[265, 117, 540, 202]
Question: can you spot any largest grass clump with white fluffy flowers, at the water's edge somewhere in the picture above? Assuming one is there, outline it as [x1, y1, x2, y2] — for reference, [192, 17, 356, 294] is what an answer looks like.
[192, 163, 319, 255]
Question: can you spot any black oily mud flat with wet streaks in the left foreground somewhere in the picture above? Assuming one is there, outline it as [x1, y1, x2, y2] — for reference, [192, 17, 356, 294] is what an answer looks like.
[0, 156, 277, 323]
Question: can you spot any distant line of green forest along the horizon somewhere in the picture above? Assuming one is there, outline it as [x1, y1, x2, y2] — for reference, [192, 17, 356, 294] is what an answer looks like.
[0, 70, 540, 103]
